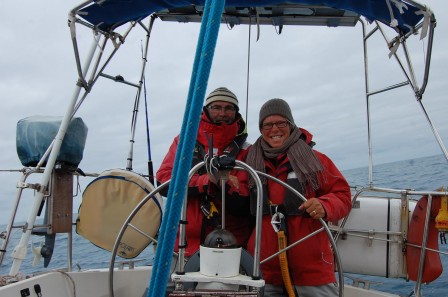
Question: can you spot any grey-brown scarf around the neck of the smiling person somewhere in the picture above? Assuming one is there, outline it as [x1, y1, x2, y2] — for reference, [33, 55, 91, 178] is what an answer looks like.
[246, 128, 324, 190]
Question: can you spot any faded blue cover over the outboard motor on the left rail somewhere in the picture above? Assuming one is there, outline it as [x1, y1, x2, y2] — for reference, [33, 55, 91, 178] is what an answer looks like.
[16, 116, 87, 167]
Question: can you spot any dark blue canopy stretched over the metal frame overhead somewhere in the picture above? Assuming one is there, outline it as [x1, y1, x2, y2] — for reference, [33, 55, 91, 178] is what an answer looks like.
[77, 0, 426, 34]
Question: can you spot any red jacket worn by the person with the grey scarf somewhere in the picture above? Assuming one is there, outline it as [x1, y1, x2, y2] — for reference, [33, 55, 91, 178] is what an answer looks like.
[248, 129, 351, 286]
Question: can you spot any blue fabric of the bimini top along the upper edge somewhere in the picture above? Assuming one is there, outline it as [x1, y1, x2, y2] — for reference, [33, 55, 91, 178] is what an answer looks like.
[79, 0, 423, 33]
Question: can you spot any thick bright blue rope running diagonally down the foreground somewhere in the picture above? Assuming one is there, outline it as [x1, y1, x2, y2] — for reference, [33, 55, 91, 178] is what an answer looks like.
[147, 0, 225, 297]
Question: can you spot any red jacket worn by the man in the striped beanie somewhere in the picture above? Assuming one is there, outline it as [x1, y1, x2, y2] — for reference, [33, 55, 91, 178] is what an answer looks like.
[156, 112, 253, 257]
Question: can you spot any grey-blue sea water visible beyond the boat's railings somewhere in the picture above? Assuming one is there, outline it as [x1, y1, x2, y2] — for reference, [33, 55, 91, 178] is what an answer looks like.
[0, 155, 448, 297]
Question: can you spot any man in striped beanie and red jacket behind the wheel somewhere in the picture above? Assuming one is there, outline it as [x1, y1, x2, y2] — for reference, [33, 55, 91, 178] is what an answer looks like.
[156, 87, 253, 257]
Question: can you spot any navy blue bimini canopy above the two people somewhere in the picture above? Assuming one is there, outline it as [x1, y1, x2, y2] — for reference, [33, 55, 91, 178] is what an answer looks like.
[77, 0, 428, 34]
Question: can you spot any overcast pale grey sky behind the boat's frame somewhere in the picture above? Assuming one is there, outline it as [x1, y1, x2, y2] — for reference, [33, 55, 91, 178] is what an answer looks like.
[0, 0, 448, 223]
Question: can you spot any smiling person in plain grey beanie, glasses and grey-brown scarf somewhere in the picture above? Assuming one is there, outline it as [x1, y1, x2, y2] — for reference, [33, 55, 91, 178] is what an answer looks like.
[246, 99, 351, 297]
